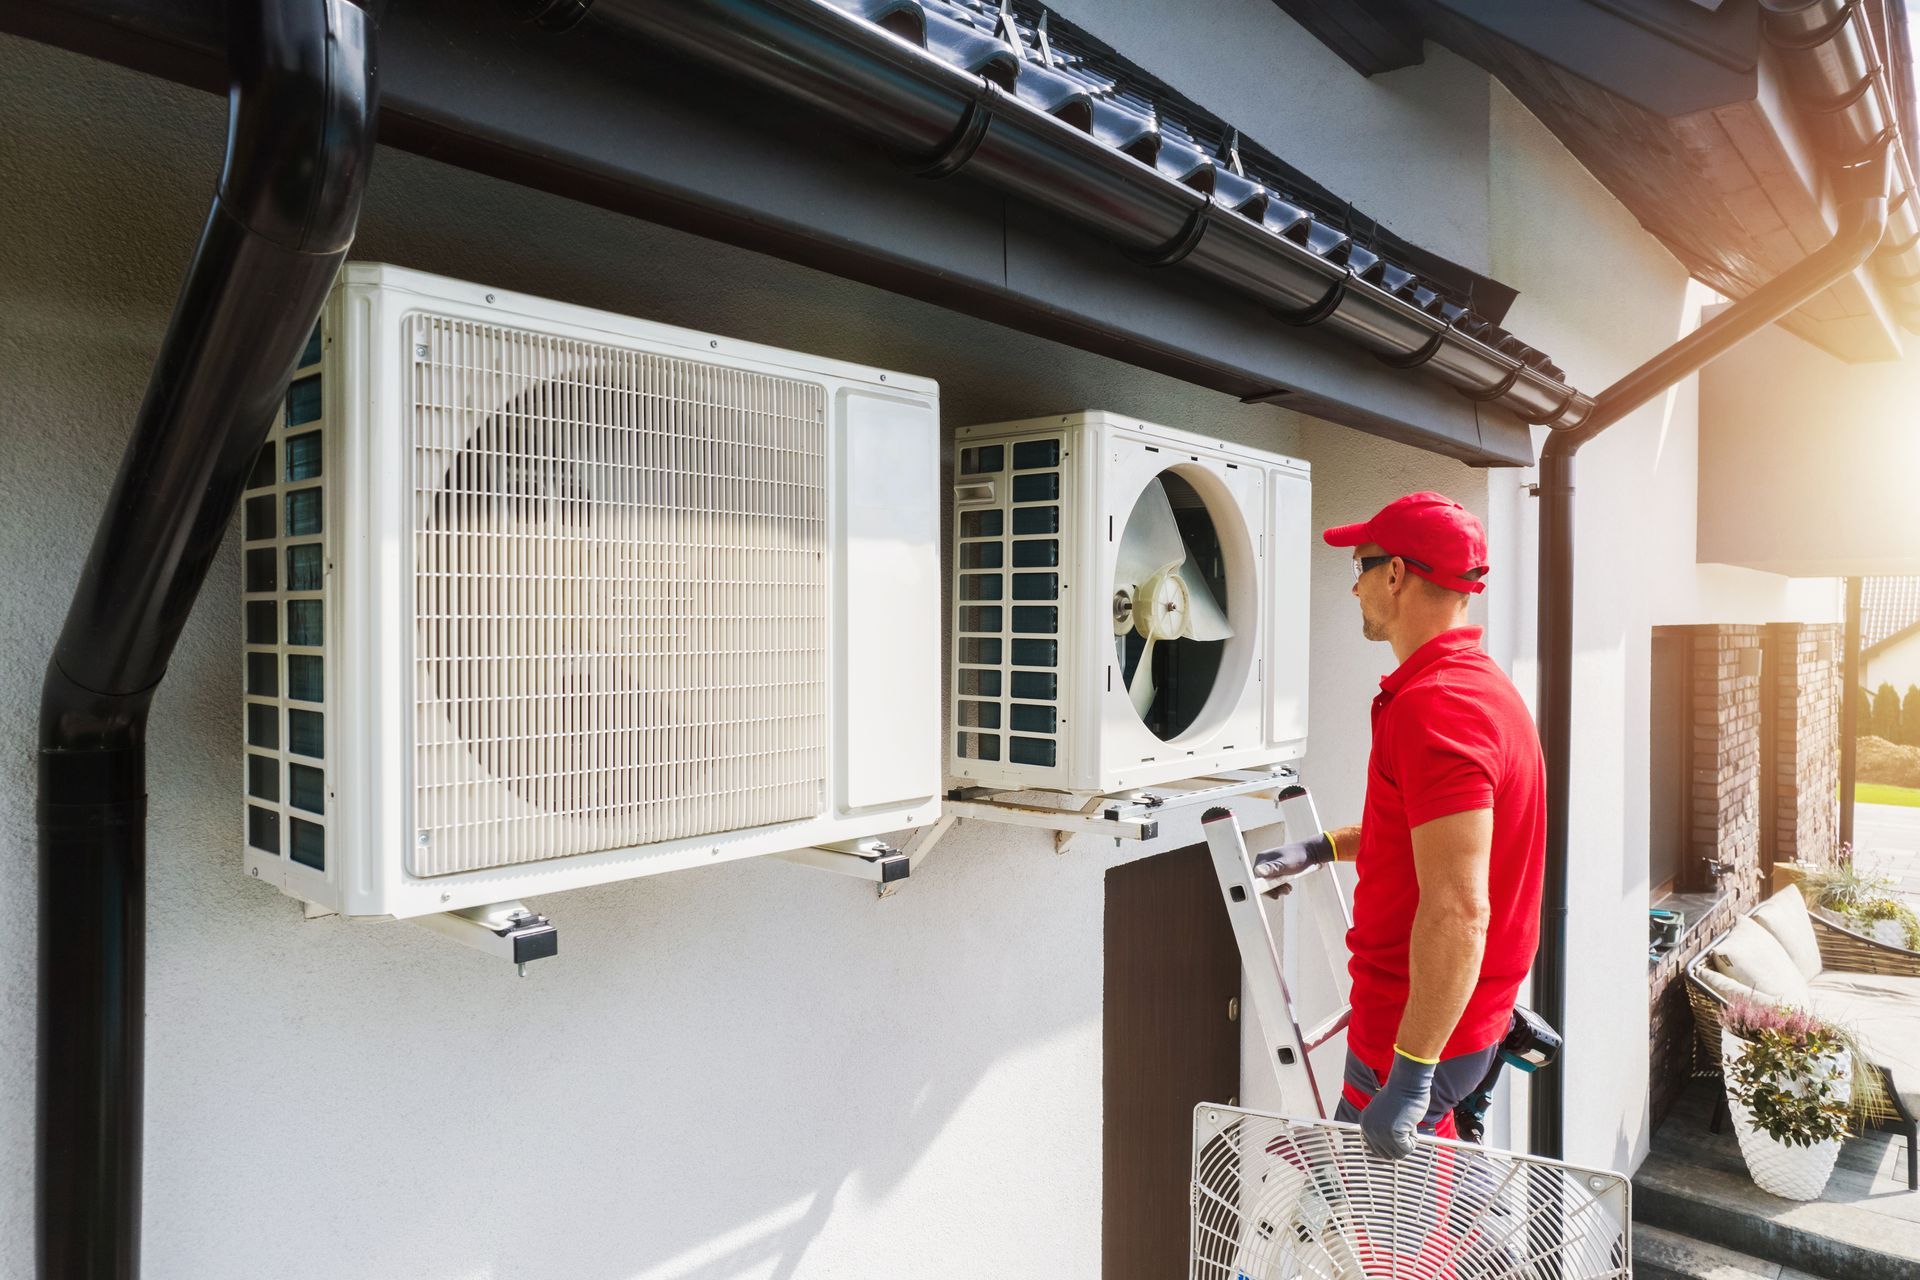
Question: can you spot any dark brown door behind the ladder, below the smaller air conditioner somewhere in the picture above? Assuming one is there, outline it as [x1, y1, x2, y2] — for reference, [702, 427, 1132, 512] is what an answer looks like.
[1100, 844, 1240, 1280]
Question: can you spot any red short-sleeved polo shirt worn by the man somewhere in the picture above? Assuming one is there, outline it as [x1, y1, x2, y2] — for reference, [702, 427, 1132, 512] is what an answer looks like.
[1346, 628, 1548, 1079]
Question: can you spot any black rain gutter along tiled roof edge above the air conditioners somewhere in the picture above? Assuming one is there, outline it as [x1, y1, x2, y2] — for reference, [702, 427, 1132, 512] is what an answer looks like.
[505, 0, 1592, 433]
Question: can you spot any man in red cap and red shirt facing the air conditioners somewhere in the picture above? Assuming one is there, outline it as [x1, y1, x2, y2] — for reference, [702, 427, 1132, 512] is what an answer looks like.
[1254, 493, 1546, 1159]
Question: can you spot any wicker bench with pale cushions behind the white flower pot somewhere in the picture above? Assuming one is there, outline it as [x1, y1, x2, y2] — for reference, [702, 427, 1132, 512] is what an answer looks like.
[1686, 887, 1920, 1190]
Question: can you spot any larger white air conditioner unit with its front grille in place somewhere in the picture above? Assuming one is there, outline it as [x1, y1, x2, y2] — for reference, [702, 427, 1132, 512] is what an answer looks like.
[242, 265, 941, 915]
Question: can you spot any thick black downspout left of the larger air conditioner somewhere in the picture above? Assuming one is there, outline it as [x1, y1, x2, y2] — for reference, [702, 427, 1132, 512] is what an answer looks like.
[36, 0, 376, 1280]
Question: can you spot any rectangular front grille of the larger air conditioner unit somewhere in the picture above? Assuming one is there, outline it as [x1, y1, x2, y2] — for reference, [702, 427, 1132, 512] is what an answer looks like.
[409, 315, 829, 875]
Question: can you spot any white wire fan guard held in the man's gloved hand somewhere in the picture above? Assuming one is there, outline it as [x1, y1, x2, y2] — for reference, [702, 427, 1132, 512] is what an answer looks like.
[1188, 1105, 1632, 1280]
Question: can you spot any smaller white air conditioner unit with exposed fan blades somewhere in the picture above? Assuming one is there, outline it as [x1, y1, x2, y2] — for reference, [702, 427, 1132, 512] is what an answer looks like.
[948, 413, 1311, 794]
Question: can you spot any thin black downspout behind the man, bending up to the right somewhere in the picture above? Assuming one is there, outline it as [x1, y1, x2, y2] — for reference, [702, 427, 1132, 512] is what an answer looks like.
[1528, 146, 1889, 1159]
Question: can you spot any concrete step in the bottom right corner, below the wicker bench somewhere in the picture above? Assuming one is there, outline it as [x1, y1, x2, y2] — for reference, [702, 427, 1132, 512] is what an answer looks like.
[1634, 1151, 1920, 1280]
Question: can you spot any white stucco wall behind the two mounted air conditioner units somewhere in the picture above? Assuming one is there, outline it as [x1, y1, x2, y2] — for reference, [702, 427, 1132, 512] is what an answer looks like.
[0, 38, 1486, 1280]
